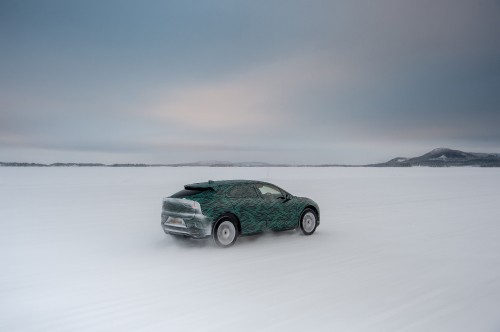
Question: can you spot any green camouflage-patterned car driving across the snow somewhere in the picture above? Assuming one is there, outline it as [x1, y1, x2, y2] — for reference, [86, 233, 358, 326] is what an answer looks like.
[161, 180, 319, 247]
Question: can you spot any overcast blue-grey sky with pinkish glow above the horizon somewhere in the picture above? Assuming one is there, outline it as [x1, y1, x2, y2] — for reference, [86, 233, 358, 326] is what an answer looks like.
[0, 0, 500, 164]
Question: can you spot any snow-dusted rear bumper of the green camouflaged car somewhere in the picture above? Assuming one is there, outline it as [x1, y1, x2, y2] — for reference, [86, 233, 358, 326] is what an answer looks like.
[161, 211, 212, 239]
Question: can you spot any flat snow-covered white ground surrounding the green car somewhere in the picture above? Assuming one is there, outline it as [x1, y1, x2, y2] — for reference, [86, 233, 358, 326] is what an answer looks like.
[0, 168, 500, 331]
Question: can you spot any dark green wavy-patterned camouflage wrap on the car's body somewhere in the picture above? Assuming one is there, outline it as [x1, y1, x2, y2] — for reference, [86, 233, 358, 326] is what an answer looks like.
[162, 180, 319, 237]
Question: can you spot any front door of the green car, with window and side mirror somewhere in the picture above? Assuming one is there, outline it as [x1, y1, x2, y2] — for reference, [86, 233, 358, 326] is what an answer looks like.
[256, 183, 296, 231]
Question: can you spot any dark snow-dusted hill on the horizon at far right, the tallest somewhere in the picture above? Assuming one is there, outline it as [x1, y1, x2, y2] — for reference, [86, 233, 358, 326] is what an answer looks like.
[367, 148, 500, 167]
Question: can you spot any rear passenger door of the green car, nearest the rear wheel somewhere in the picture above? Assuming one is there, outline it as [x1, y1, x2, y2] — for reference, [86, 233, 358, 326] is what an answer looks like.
[226, 184, 266, 235]
